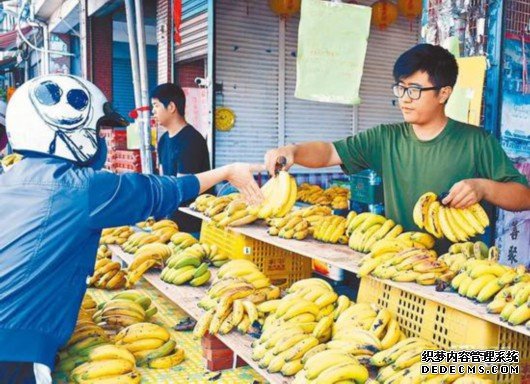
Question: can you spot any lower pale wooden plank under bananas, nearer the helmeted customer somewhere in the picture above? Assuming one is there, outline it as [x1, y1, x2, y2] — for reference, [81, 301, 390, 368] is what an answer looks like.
[108, 245, 293, 384]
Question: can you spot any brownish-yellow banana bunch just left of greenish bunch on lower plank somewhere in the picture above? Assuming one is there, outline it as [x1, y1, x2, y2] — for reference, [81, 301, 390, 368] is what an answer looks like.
[126, 242, 172, 288]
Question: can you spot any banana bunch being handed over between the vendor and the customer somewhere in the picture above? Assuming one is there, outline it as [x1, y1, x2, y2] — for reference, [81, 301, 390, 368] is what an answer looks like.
[248, 171, 297, 219]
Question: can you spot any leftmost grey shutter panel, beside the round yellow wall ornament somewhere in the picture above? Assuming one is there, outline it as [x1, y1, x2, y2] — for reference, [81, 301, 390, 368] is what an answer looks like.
[215, 0, 279, 166]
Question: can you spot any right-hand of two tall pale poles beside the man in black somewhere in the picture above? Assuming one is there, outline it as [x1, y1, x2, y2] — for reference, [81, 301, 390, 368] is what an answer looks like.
[134, 0, 153, 173]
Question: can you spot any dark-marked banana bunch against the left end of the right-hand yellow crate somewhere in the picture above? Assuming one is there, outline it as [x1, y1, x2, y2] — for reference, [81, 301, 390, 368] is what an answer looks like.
[327, 303, 404, 365]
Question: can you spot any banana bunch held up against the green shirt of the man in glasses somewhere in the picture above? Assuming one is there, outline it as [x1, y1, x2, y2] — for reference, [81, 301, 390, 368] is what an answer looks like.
[413, 192, 490, 243]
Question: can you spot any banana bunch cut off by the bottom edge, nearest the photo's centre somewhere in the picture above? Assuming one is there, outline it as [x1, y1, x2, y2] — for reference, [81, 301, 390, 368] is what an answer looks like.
[293, 347, 369, 384]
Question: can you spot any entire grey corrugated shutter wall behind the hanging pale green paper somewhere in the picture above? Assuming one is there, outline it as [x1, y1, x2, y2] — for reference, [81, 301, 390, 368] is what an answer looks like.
[216, 0, 419, 172]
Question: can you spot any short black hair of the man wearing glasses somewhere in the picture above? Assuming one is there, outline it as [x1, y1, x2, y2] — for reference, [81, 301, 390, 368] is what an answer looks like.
[394, 44, 458, 87]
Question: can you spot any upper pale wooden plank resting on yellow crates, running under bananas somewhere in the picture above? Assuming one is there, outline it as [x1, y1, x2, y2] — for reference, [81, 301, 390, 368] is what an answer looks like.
[180, 208, 530, 336]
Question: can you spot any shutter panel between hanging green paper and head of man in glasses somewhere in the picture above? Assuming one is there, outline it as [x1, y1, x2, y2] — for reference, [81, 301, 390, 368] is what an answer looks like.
[359, 1, 419, 131]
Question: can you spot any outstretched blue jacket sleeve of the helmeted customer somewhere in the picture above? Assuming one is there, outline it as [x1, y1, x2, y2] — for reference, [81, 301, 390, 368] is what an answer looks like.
[88, 172, 199, 229]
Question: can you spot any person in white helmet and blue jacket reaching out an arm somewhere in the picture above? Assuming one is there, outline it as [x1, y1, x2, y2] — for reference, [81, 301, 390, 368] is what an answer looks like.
[0, 75, 261, 383]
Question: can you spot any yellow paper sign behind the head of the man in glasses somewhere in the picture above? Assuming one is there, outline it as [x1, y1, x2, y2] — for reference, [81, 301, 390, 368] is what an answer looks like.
[445, 56, 486, 126]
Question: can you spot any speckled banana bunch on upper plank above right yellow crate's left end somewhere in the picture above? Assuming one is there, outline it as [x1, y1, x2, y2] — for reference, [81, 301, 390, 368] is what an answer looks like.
[358, 239, 444, 285]
